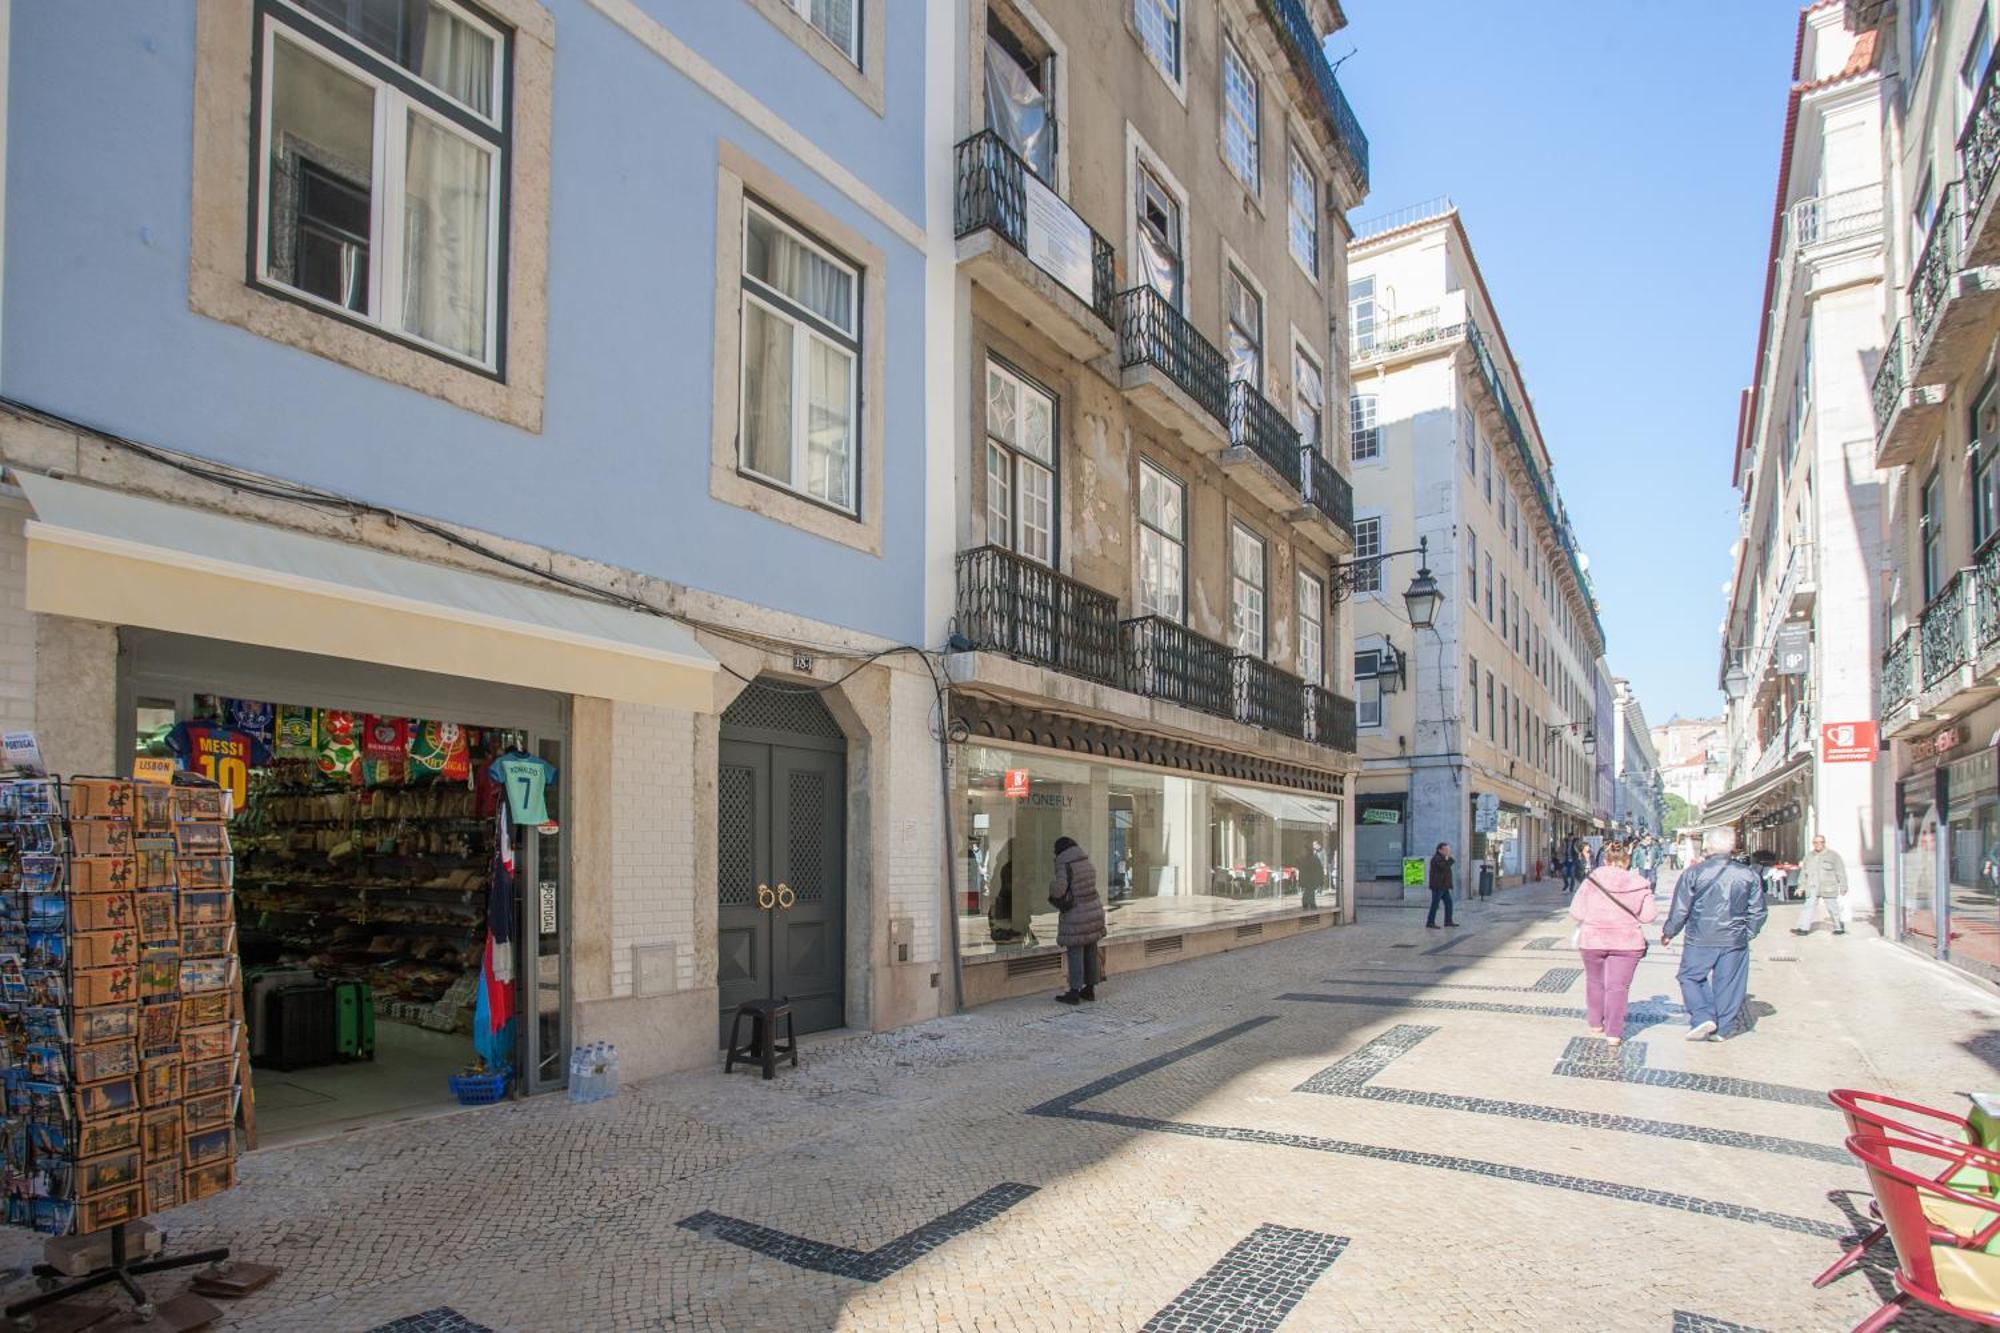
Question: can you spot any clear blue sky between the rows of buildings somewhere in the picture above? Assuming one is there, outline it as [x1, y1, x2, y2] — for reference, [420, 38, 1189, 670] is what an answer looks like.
[1328, 0, 1798, 723]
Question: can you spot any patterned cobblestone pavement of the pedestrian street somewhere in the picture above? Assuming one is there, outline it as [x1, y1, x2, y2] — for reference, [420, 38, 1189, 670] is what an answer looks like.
[0, 872, 2000, 1333]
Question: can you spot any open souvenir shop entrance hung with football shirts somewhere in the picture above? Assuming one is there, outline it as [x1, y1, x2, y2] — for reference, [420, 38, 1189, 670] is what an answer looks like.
[118, 628, 570, 1145]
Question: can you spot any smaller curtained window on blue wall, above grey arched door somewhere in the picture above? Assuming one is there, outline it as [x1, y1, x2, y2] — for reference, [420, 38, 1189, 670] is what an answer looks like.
[740, 204, 860, 512]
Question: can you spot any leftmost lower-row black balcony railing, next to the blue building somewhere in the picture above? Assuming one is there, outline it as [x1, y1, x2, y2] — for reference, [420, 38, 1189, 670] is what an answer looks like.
[958, 546, 1118, 685]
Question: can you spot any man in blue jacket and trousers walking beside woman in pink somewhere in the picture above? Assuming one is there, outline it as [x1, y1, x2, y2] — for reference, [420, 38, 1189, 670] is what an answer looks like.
[1660, 827, 1768, 1041]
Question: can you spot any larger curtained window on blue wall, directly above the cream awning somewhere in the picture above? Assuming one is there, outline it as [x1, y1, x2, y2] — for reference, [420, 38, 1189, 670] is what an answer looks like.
[254, 0, 508, 370]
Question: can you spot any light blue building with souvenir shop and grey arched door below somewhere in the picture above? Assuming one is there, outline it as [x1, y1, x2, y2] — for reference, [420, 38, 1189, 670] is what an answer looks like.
[0, 0, 950, 1112]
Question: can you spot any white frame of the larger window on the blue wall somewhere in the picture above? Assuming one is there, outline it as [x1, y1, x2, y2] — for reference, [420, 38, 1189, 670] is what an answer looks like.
[250, 10, 510, 376]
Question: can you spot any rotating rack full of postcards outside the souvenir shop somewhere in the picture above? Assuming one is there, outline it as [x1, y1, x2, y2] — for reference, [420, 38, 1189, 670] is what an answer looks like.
[0, 764, 274, 1329]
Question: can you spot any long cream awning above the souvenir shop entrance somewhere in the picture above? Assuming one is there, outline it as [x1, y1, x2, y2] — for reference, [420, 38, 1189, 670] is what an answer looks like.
[18, 472, 718, 713]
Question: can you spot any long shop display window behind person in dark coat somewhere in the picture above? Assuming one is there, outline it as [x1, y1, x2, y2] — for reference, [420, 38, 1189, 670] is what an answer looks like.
[956, 745, 1340, 955]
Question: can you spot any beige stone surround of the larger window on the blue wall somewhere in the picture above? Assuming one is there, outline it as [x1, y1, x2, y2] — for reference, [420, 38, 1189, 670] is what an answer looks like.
[188, 0, 556, 434]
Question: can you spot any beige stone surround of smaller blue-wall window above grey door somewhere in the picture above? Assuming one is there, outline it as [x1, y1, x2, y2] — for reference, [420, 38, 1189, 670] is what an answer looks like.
[708, 143, 888, 556]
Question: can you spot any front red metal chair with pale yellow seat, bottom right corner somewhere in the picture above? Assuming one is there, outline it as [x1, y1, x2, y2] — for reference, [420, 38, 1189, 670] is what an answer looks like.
[1848, 1135, 2000, 1333]
